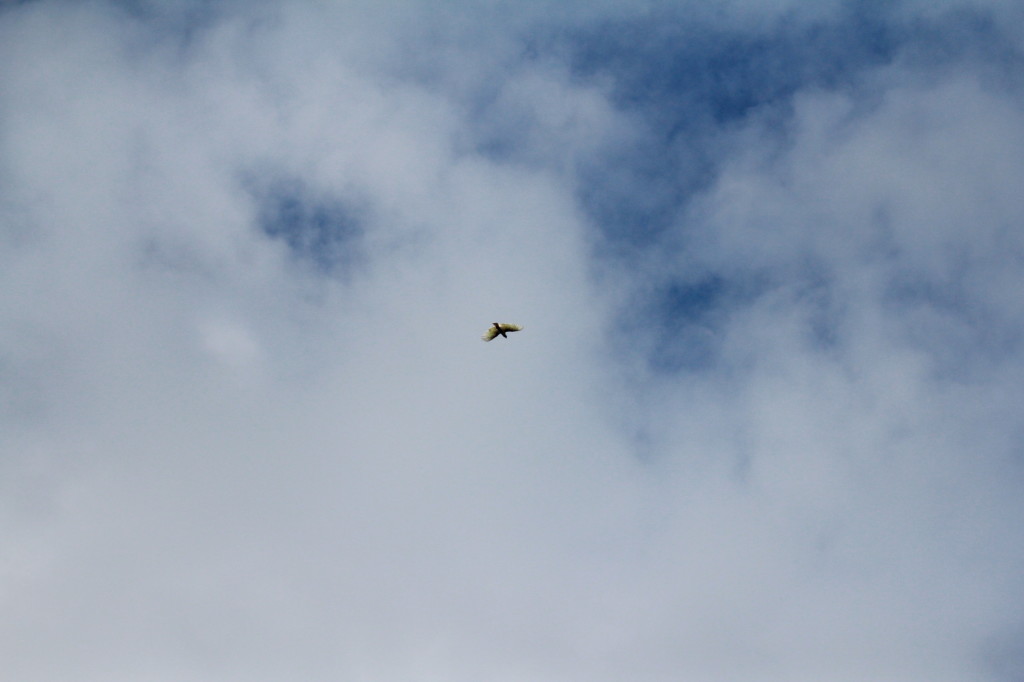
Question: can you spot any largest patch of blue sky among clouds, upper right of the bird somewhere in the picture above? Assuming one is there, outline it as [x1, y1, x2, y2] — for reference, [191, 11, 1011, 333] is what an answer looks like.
[544, 2, 1019, 372]
